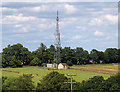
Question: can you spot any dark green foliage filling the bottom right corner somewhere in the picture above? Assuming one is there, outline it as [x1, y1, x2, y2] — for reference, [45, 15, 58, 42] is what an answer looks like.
[80, 73, 120, 92]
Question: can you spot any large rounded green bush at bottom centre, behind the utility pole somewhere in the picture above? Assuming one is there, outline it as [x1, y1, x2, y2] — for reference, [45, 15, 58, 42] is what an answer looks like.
[37, 71, 80, 92]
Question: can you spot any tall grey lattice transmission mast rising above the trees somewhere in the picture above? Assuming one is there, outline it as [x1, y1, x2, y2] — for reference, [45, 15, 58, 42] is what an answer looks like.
[55, 11, 61, 69]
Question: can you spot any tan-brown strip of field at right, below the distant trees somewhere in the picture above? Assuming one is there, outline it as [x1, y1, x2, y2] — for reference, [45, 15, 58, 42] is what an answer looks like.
[71, 63, 118, 75]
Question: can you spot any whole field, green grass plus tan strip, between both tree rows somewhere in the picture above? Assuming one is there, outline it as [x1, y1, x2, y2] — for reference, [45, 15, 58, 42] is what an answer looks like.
[2, 64, 117, 85]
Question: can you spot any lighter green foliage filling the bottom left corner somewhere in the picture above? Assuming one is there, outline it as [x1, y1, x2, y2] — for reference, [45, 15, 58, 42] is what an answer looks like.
[2, 74, 35, 90]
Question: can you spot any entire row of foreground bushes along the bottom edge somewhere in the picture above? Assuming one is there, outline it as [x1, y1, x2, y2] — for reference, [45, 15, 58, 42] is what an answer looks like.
[2, 71, 120, 92]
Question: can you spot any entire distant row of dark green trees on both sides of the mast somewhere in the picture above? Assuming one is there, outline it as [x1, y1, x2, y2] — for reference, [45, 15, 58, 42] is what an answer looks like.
[2, 43, 120, 67]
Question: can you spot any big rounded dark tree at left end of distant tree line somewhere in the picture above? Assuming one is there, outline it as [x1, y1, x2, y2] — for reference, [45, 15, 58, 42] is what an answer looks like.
[2, 43, 32, 67]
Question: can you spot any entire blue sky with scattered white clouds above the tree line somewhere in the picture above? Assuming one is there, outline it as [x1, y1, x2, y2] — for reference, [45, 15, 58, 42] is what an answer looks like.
[0, 2, 118, 52]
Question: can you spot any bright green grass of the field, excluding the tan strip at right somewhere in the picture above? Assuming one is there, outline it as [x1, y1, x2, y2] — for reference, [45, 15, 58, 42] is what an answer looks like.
[2, 66, 110, 85]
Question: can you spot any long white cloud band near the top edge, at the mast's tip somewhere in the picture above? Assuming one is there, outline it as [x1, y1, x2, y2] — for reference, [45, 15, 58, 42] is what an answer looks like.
[20, 4, 78, 14]
